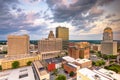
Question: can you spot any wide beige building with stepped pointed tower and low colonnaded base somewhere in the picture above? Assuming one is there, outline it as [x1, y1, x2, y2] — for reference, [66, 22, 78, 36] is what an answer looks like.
[38, 31, 62, 59]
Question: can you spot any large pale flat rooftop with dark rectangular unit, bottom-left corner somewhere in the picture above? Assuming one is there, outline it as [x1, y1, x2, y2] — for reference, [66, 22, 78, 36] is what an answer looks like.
[0, 66, 35, 80]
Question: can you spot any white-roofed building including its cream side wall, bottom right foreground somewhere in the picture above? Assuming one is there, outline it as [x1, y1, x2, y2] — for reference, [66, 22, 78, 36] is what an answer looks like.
[77, 68, 114, 80]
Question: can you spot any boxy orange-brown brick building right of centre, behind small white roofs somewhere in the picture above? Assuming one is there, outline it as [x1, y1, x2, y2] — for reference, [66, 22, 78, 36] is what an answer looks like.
[68, 42, 90, 59]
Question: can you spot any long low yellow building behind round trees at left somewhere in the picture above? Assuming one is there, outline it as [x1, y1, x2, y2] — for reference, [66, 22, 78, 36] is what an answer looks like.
[0, 54, 41, 70]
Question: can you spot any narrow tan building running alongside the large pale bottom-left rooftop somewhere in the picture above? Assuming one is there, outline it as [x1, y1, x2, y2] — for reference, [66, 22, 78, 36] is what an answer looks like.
[32, 61, 50, 80]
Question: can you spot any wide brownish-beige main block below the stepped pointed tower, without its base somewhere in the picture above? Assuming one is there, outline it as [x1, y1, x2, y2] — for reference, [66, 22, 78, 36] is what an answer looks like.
[38, 38, 62, 52]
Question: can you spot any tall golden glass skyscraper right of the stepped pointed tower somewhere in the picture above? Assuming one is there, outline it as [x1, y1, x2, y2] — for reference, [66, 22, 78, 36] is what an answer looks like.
[56, 26, 69, 50]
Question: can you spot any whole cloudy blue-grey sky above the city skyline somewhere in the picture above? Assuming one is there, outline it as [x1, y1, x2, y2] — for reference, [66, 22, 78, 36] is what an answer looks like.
[0, 0, 120, 40]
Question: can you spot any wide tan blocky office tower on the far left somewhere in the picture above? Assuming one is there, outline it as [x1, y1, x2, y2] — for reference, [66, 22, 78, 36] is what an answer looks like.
[8, 35, 29, 55]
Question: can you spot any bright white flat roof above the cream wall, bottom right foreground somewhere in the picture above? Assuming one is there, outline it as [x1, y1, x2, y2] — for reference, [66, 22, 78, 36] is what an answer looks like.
[78, 68, 113, 80]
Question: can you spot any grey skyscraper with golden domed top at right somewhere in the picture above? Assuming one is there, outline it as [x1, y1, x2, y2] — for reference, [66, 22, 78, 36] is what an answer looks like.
[101, 27, 117, 55]
